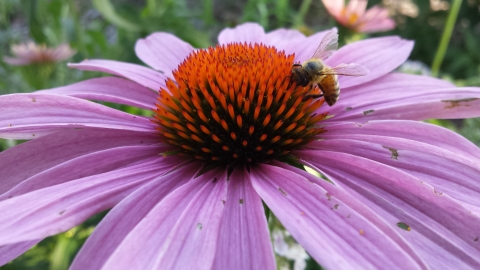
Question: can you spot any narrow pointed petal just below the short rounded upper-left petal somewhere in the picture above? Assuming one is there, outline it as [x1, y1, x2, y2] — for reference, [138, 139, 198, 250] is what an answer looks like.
[68, 59, 167, 91]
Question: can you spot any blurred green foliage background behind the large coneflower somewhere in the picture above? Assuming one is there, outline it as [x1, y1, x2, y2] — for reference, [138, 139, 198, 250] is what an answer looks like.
[0, 0, 480, 270]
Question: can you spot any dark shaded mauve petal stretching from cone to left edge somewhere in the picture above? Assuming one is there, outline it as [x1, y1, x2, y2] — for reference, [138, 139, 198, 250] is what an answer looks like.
[0, 128, 158, 194]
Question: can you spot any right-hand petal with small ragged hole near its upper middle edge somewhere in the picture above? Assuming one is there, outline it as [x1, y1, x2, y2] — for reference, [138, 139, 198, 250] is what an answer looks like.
[306, 139, 480, 214]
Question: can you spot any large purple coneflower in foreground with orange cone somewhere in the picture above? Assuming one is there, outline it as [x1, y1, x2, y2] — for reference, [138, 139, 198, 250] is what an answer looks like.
[0, 23, 480, 269]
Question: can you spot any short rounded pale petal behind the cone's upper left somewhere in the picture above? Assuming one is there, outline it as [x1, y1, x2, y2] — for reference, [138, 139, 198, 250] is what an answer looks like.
[135, 32, 194, 77]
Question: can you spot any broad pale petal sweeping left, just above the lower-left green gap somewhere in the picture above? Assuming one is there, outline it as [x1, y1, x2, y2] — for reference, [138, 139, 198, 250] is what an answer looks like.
[0, 157, 178, 245]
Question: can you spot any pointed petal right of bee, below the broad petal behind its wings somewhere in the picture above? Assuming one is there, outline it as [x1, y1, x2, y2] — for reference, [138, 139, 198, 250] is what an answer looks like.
[321, 73, 454, 114]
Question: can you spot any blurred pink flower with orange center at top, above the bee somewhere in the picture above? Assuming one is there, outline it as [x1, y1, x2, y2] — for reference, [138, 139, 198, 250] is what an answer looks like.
[322, 0, 395, 33]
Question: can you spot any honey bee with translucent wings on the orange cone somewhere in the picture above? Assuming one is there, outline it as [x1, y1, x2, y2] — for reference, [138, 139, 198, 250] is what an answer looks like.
[290, 30, 369, 106]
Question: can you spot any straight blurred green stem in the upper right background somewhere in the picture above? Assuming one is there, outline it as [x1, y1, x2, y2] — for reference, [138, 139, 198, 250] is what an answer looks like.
[432, 0, 462, 77]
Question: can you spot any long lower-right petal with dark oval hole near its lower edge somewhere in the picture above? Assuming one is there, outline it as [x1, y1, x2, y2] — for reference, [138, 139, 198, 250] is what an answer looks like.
[302, 151, 480, 269]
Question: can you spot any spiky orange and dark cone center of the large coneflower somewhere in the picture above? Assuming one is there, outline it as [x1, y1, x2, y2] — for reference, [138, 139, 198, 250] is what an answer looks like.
[153, 43, 326, 168]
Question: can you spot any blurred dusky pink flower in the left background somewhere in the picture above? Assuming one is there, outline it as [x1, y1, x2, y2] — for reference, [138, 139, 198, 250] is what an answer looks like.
[3, 41, 76, 66]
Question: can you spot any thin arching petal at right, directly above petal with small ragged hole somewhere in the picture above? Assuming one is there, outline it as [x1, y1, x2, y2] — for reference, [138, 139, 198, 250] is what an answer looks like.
[322, 120, 480, 160]
